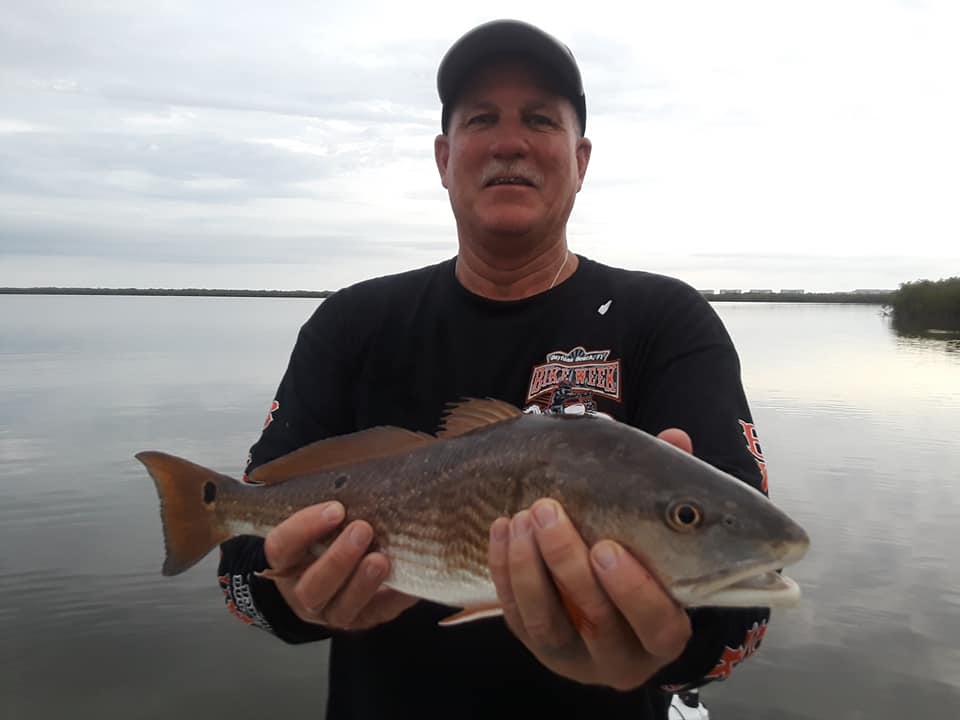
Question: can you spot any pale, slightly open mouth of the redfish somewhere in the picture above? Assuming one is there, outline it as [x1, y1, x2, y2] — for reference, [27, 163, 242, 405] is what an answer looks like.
[671, 548, 805, 607]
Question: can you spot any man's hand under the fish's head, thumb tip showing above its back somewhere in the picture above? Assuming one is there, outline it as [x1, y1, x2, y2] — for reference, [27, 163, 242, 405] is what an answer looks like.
[489, 429, 692, 690]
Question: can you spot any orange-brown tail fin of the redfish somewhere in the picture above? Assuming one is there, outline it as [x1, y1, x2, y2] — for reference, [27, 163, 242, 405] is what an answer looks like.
[135, 451, 231, 575]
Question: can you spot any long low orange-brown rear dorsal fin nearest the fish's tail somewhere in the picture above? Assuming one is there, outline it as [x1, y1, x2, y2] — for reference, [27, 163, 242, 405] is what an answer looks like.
[249, 425, 436, 485]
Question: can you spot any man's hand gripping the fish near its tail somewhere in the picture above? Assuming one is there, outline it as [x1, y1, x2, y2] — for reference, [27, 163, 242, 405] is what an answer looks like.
[264, 502, 417, 630]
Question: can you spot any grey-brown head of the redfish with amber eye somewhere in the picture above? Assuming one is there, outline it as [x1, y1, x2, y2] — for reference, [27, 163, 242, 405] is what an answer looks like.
[568, 423, 810, 607]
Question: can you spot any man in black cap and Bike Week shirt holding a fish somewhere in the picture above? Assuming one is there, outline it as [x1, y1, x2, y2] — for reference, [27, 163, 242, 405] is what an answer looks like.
[220, 21, 768, 720]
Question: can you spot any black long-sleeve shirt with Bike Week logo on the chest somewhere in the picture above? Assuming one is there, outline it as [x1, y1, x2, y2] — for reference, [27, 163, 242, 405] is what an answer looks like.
[219, 256, 769, 720]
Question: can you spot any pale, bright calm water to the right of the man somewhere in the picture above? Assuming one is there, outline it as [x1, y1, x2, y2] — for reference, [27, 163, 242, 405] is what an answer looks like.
[704, 305, 960, 720]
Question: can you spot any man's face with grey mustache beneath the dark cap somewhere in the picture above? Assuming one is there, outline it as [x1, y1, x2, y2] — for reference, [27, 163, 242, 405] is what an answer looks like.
[434, 62, 590, 250]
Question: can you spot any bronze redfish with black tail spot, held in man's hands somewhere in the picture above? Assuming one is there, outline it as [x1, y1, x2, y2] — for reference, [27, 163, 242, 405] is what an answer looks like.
[136, 399, 810, 623]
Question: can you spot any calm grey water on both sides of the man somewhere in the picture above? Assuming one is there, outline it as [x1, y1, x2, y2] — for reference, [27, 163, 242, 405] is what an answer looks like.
[0, 296, 960, 720]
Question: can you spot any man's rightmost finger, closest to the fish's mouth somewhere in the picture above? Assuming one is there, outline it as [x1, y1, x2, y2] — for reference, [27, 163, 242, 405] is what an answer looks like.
[590, 540, 691, 665]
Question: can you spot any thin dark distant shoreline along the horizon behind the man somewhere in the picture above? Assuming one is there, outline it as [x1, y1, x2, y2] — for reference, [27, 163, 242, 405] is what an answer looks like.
[0, 287, 893, 305]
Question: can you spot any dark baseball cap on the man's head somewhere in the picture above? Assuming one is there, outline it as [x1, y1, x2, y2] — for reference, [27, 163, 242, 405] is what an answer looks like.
[437, 20, 587, 135]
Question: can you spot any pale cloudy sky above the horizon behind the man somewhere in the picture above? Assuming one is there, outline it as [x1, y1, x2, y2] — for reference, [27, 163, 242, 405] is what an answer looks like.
[0, 0, 960, 291]
